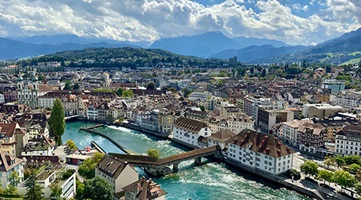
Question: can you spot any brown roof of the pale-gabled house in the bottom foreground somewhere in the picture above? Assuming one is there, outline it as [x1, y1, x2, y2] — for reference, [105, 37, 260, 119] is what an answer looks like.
[97, 154, 128, 179]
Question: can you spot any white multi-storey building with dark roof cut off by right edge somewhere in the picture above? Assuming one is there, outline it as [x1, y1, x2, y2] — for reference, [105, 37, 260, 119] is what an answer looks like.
[335, 125, 361, 156]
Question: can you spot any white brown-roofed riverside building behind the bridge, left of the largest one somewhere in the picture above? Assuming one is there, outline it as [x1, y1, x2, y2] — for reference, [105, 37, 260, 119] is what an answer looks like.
[173, 117, 211, 147]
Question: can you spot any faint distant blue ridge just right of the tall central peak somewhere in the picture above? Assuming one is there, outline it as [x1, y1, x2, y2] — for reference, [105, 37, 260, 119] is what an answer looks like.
[232, 37, 288, 49]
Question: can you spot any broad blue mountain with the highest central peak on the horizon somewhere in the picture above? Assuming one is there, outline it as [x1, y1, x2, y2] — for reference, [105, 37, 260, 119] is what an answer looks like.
[150, 32, 238, 58]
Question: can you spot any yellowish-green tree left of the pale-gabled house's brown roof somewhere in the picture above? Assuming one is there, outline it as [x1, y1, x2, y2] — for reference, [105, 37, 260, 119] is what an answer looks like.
[78, 152, 104, 179]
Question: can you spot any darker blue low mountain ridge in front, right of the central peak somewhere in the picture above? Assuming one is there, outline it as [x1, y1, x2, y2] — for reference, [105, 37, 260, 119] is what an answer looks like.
[211, 45, 307, 63]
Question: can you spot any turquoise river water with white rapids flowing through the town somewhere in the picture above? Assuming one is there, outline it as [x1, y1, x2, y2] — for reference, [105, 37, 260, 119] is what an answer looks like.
[63, 121, 308, 200]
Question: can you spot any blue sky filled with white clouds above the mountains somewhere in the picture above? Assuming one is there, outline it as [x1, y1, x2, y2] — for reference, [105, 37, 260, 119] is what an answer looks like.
[0, 0, 361, 45]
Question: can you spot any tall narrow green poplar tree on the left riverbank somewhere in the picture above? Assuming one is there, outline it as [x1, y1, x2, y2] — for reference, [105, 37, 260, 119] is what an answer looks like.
[49, 99, 65, 145]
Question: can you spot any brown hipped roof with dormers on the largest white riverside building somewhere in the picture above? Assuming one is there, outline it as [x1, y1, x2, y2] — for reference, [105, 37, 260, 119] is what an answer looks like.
[227, 129, 294, 158]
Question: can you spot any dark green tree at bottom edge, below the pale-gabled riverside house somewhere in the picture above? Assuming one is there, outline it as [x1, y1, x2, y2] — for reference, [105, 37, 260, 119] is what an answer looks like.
[83, 177, 113, 200]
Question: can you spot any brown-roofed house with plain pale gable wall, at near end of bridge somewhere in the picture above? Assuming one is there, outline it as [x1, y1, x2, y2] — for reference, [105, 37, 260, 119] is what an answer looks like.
[95, 154, 138, 194]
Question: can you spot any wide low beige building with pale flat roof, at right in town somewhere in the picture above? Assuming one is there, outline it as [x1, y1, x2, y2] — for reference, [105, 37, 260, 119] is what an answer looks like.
[302, 104, 342, 118]
